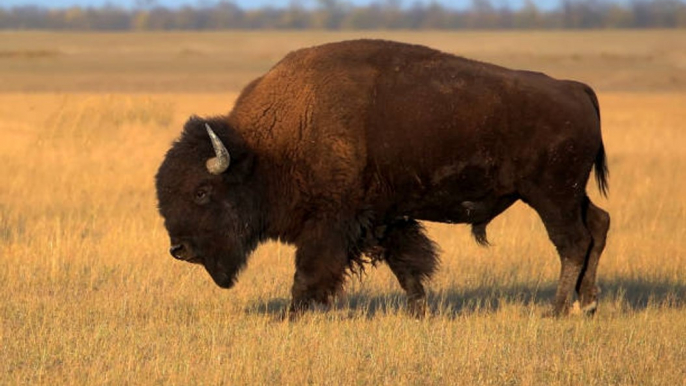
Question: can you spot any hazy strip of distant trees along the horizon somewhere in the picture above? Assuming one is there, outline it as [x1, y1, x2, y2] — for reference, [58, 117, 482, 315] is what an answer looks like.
[0, 0, 686, 31]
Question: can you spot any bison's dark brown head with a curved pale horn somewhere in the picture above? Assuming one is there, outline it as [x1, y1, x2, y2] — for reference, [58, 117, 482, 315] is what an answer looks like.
[156, 117, 261, 288]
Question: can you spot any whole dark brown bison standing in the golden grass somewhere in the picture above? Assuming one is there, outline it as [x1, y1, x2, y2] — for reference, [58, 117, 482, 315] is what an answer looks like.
[156, 40, 610, 315]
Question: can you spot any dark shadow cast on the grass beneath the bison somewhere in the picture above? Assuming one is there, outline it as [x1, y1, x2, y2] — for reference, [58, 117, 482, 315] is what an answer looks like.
[245, 279, 686, 318]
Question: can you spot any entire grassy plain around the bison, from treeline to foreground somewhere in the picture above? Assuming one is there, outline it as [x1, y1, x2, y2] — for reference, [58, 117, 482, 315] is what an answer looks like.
[0, 31, 686, 385]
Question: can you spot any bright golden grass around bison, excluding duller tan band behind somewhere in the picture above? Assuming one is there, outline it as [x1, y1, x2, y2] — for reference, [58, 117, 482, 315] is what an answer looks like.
[0, 89, 686, 384]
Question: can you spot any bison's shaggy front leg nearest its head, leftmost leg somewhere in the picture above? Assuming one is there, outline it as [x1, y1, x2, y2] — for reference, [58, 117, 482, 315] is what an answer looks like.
[290, 234, 348, 315]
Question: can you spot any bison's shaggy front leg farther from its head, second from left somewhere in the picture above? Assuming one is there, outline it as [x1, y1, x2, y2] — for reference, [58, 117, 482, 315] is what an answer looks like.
[380, 219, 438, 317]
